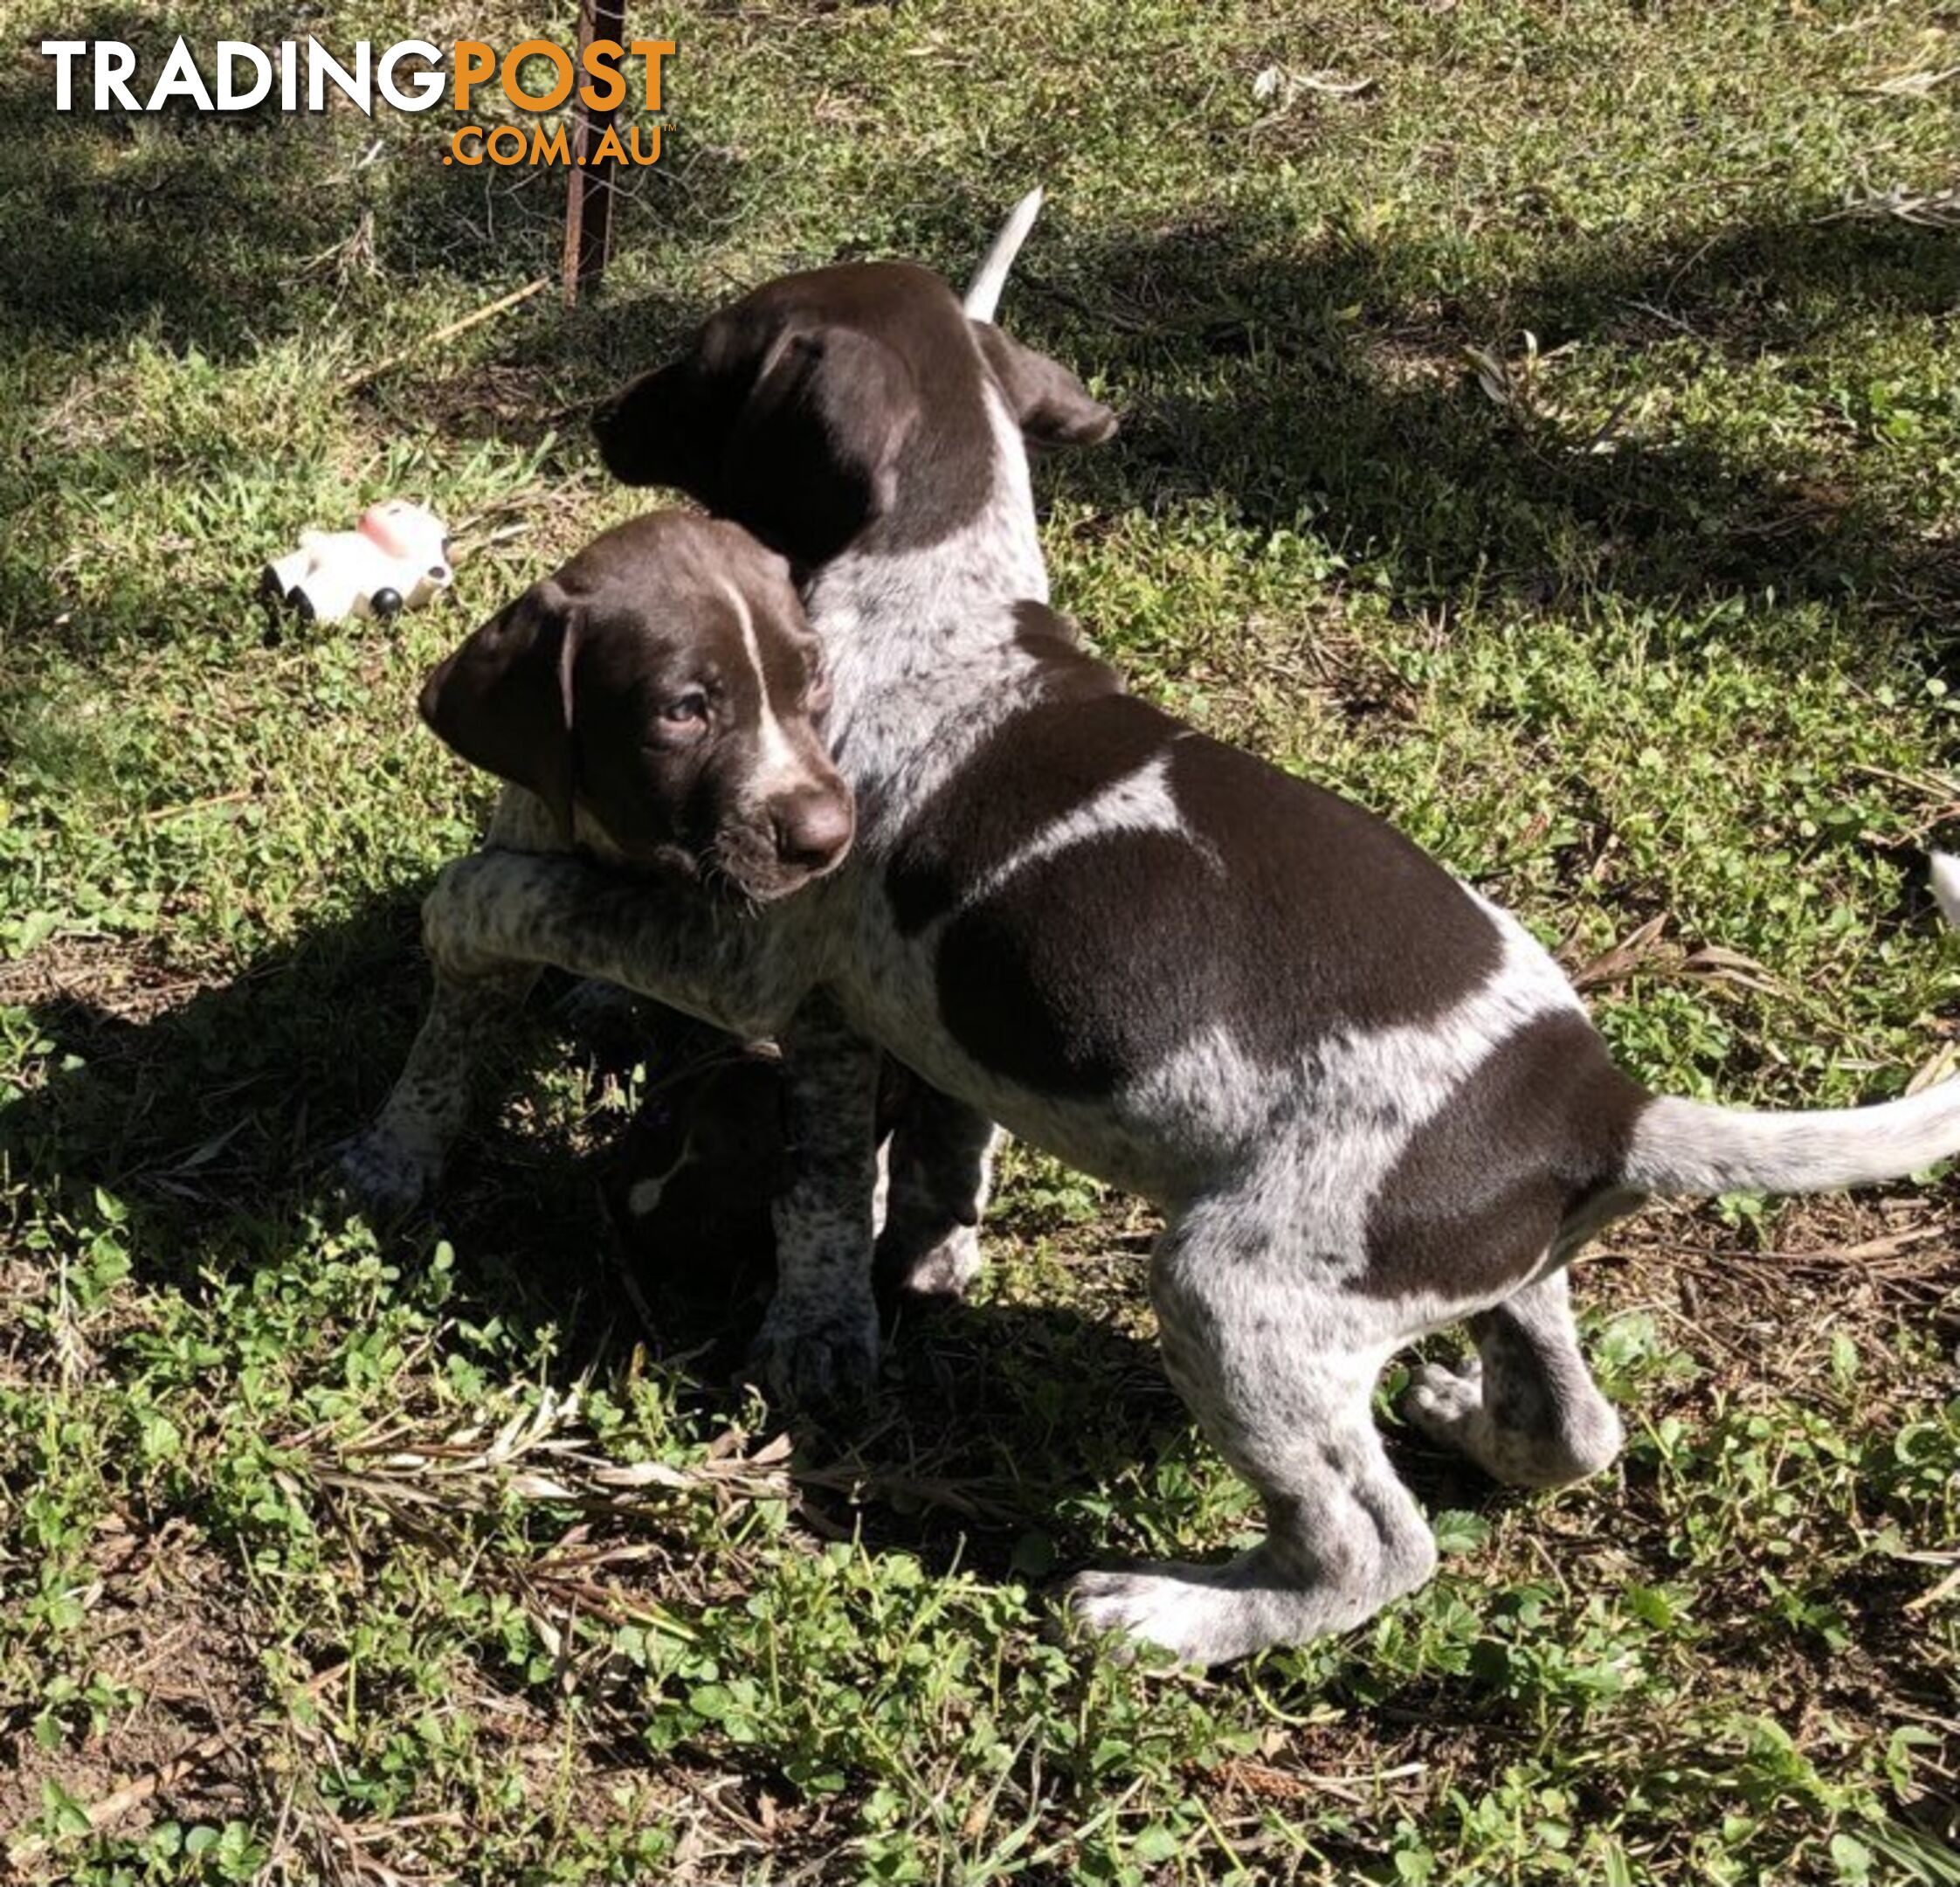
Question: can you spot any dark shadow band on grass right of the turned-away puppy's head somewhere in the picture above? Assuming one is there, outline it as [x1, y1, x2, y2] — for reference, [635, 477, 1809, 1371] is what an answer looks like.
[1007, 205, 1960, 654]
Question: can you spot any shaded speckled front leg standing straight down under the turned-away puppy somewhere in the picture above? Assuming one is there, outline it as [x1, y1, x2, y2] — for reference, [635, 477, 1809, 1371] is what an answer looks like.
[753, 992, 878, 1401]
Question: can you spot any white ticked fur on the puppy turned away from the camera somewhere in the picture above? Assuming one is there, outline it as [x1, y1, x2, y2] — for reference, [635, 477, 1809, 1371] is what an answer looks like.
[368, 198, 1960, 1663]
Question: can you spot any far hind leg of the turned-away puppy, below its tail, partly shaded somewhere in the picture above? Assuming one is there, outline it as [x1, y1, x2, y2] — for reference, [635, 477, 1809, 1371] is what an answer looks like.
[1401, 1266, 1623, 1487]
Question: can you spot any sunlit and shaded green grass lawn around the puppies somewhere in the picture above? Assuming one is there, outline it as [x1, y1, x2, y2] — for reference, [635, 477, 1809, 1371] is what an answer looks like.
[0, 0, 1960, 1884]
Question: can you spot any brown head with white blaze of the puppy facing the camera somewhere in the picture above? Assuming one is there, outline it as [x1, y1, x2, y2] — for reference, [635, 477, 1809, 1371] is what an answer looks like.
[421, 511, 854, 903]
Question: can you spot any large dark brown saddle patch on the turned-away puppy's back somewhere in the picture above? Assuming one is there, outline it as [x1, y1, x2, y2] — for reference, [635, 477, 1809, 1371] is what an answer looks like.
[886, 666, 1500, 1096]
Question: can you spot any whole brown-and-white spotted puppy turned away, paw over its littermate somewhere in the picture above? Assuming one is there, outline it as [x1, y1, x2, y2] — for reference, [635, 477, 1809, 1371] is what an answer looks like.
[368, 228, 1960, 1663]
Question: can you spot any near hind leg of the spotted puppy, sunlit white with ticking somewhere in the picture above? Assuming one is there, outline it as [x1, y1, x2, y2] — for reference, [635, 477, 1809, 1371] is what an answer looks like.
[1068, 1207, 1437, 1666]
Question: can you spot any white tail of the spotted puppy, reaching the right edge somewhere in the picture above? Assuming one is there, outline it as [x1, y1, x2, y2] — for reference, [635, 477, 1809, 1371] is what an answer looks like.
[1621, 853, 1960, 1197]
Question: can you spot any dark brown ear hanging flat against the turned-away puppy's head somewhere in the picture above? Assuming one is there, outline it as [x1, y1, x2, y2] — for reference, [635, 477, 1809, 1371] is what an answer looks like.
[717, 328, 919, 564]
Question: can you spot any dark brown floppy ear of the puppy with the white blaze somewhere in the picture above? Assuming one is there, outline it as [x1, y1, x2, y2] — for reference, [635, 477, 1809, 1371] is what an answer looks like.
[421, 580, 578, 845]
